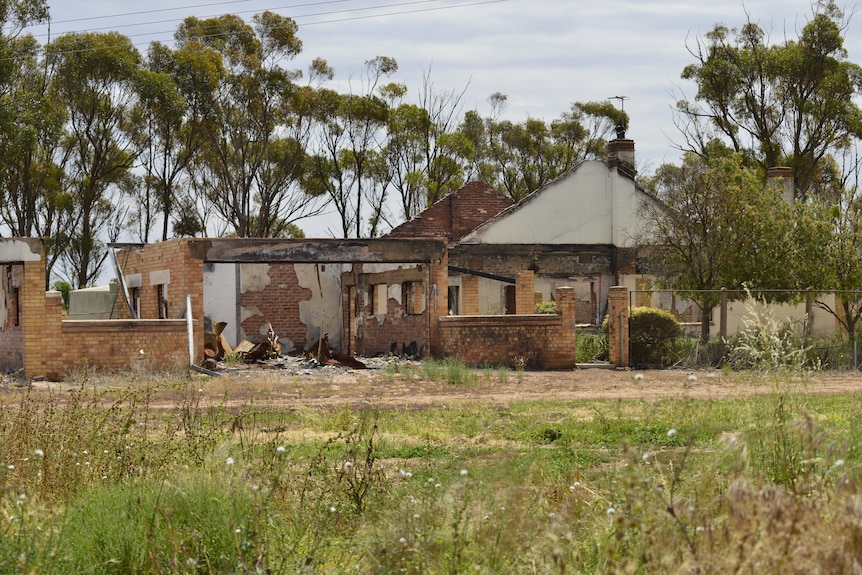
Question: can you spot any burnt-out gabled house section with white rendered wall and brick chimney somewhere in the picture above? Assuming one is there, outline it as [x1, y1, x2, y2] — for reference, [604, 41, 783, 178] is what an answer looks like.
[390, 137, 657, 325]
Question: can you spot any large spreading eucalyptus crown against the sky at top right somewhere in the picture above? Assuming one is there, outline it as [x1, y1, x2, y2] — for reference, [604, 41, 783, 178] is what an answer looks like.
[676, 0, 862, 198]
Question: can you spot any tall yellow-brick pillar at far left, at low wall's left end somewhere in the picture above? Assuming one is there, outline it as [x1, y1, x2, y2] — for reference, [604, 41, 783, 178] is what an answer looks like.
[19, 258, 47, 379]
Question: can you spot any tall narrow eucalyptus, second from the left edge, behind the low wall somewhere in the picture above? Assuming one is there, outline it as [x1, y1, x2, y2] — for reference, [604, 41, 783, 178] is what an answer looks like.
[46, 32, 141, 287]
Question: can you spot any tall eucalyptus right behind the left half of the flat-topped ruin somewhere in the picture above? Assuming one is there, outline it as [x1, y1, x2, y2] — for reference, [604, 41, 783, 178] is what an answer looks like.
[175, 12, 322, 237]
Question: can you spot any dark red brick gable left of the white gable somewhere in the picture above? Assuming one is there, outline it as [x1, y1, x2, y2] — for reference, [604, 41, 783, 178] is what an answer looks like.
[384, 182, 515, 242]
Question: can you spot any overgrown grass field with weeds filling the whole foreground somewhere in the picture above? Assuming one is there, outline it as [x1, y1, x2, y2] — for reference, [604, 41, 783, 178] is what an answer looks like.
[0, 362, 862, 574]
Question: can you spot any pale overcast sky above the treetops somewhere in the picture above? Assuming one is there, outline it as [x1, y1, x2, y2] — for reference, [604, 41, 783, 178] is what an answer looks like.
[27, 0, 862, 234]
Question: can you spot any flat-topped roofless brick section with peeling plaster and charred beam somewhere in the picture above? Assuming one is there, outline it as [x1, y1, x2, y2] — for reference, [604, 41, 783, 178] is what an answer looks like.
[118, 238, 447, 355]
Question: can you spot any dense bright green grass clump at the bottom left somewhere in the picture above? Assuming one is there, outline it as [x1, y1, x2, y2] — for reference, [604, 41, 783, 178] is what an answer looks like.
[52, 476, 261, 575]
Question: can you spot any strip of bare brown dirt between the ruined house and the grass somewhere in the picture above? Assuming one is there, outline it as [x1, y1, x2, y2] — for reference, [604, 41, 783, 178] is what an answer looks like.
[10, 360, 862, 409]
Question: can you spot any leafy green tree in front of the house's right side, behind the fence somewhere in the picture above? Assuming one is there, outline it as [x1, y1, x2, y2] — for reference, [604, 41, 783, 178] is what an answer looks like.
[641, 148, 828, 341]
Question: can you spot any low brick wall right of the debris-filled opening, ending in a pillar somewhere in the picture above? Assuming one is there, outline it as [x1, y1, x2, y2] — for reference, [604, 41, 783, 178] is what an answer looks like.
[439, 315, 575, 369]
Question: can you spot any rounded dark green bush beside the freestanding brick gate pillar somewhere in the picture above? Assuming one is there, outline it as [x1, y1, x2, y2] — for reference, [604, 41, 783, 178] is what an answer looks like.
[629, 307, 682, 366]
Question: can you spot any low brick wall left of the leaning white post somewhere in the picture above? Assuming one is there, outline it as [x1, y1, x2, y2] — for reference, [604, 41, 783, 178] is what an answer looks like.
[45, 319, 189, 380]
